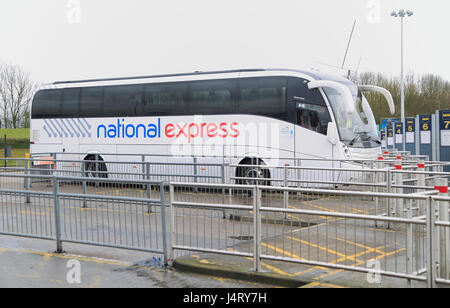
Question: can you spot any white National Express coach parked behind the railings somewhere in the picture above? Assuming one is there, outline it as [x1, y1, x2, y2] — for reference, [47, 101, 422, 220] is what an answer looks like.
[30, 69, 394, 184]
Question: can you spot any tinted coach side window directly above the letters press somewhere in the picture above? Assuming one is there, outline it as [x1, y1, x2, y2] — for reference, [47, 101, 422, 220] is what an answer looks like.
[190, 80, 236, 114]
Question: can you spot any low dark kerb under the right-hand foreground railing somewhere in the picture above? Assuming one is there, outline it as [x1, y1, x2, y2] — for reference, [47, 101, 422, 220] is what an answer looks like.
[173, 258, 310, 288]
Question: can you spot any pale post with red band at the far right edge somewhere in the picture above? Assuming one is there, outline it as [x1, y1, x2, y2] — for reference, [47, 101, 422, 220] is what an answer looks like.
[435, 178, 450, 279]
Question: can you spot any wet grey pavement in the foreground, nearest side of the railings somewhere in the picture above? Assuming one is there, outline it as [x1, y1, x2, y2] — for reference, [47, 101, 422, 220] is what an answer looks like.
[0, 236, 273, 288]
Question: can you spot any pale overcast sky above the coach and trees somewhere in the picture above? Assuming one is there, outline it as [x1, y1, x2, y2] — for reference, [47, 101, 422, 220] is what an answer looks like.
[0, 0, 450, 82]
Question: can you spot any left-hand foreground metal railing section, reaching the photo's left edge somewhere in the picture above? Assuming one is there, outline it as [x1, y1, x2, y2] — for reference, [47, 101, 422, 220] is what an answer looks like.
[0, 174, 168, 264]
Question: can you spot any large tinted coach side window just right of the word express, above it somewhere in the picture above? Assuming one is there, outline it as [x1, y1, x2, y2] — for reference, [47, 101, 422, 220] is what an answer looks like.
[238, 78, 287, 120]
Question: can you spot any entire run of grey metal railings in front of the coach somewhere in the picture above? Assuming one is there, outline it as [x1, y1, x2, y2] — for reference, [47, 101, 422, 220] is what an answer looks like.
[0, 153, 450, 287]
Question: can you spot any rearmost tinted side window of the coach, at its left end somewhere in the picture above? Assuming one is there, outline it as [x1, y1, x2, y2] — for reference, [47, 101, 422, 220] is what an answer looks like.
[32, 90, 62, 118]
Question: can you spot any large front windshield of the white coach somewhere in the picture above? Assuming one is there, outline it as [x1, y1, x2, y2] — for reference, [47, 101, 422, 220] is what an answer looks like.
[324, 84, 381, 148]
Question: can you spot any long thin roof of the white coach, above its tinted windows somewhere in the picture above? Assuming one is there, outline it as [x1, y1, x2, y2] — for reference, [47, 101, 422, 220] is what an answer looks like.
[53, 69, 349, 85]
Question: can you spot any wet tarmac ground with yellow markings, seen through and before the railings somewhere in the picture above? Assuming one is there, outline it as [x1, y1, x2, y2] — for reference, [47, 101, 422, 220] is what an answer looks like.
[0, 177, 442, 288]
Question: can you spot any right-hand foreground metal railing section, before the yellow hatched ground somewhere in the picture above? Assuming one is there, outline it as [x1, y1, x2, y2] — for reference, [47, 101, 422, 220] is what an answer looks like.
[170, 183, 450, 286]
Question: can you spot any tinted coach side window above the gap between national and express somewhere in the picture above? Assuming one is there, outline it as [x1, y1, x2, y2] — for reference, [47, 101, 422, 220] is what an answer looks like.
[143, 83, 188, 116]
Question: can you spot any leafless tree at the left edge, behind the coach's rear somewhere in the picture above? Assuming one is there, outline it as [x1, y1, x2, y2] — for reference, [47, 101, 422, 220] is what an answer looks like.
[0, 64, 36, 128]
